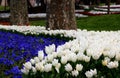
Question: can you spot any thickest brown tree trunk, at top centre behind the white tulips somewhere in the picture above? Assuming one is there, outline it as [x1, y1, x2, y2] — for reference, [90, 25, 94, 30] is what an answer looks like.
[46, 0, 77, 30]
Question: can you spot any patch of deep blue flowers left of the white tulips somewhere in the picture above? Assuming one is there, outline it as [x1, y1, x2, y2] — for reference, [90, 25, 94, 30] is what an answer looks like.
[0, 31, 67, 78]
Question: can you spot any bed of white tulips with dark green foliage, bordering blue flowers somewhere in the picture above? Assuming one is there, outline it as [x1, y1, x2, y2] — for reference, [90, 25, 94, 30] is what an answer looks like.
[0, 26, 120, 78]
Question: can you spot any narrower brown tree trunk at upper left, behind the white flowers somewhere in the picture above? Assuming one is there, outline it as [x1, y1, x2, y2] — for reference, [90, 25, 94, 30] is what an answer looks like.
[10, 0, 29, 25]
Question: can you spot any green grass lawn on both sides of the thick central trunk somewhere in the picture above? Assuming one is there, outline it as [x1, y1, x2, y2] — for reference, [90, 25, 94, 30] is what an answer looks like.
[30, 14, 120, 31]
